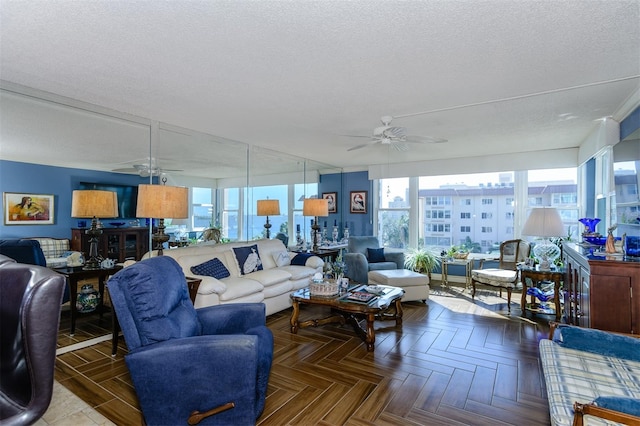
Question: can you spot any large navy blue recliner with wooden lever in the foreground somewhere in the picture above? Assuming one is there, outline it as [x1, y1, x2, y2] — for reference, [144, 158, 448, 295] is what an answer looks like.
[107, 256, 273, 425]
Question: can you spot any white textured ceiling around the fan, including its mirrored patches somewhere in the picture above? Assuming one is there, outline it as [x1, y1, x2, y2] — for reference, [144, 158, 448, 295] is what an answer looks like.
[0, 0, 640, 177]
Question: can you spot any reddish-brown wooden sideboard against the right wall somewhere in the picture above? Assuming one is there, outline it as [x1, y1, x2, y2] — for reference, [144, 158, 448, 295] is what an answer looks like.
[563, 243, 640, 334]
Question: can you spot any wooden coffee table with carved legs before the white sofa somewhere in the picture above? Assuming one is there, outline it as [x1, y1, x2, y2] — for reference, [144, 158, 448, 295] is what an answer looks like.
[290, 285, 404, 351]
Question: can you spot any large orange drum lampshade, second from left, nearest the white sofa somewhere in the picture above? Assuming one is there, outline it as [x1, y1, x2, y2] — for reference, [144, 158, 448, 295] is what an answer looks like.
[136, 185, 189, 219]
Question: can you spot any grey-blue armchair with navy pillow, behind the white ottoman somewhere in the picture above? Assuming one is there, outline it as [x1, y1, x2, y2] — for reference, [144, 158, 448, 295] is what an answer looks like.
[342, 236, 404, 284]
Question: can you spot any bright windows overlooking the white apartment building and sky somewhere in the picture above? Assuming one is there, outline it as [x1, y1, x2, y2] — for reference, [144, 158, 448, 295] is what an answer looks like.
[378, 168, 578, 252]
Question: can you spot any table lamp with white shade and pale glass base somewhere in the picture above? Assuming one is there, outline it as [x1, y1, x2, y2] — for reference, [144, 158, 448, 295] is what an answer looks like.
[522, 207, 564, 271]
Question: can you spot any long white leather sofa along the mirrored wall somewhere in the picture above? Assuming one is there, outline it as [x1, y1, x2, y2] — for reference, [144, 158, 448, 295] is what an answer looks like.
[144, 239, 324, 315]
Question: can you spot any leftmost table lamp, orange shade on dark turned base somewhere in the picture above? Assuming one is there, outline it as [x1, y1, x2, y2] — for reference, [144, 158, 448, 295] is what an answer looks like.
[71, 189, 118, 270]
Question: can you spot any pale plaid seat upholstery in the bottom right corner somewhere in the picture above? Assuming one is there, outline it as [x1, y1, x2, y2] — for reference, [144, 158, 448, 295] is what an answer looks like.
[539, 340, 640, 425]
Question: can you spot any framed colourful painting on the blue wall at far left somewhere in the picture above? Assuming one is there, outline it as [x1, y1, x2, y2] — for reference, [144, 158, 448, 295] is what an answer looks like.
[3, 192, 53, 225]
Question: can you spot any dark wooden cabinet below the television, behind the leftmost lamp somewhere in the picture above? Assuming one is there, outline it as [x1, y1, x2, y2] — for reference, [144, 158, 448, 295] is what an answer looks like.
[71, 227, 149, 262]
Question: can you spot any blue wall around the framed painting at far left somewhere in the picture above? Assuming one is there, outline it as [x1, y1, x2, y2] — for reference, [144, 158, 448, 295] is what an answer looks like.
[0, 160, 149, 238]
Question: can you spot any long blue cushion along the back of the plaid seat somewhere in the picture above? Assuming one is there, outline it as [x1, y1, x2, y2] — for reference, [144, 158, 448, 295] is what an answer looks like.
[558, 327, 640, 361]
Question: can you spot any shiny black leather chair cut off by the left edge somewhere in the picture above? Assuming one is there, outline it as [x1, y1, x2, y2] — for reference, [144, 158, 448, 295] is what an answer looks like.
[0, 255, 65, 425]
